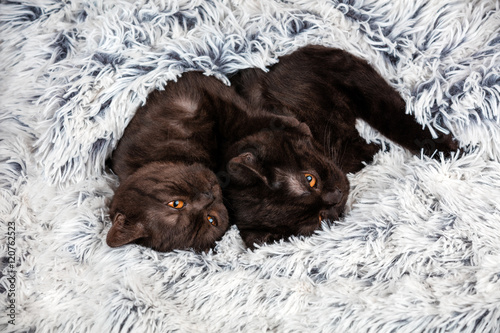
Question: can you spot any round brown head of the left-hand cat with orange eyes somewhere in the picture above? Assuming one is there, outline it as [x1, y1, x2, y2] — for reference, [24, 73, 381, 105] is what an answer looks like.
[106, 162, 229, 251]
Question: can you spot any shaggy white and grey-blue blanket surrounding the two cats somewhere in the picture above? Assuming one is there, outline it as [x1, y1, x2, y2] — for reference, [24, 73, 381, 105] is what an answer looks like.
[0, 0, 500, 332]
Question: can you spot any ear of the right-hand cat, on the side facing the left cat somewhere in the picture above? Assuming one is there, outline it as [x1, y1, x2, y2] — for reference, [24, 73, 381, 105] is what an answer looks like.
[227, 152, 268, 185]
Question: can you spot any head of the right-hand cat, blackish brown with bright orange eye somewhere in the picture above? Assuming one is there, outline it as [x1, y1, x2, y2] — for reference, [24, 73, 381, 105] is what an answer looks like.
[224, 126, 349, 247]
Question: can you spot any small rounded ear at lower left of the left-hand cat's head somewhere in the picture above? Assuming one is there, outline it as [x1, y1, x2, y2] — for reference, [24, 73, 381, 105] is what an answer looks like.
[106, 213, 147, 247]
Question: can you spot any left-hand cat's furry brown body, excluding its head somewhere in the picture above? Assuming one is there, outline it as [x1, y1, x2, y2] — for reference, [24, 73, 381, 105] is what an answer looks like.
[111, 72, 307, 180]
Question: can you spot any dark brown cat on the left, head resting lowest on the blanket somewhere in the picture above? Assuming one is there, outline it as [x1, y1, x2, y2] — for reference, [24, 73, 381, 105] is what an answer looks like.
[107, 72, 310, 251]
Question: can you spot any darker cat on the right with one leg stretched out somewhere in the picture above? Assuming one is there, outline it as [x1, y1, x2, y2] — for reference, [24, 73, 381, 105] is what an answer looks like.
[225, 46, 457, 247]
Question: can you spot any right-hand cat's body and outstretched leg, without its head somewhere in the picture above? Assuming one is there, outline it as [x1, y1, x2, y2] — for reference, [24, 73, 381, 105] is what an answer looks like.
[231, 45, 457, 172]
